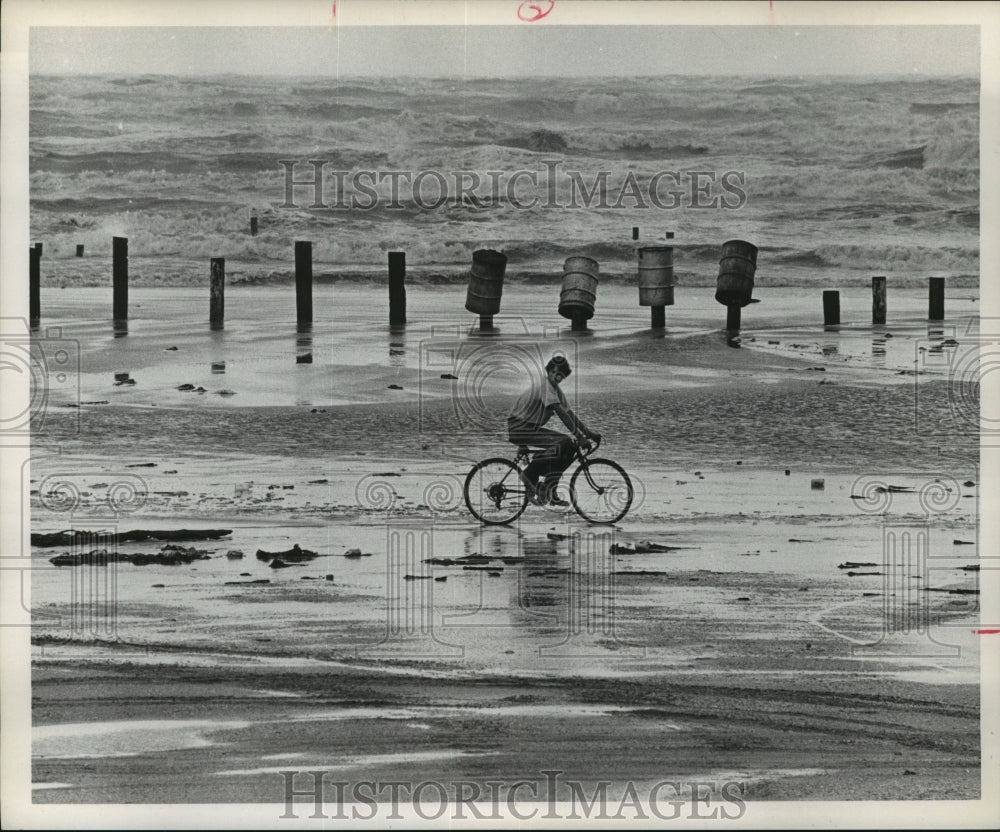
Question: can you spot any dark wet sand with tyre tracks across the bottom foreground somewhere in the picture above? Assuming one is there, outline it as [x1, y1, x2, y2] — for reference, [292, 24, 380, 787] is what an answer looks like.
[34, 648, 979, 818]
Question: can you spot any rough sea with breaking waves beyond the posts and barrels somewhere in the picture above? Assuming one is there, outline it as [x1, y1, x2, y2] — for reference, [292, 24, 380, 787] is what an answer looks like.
[30, 75, 979, 287]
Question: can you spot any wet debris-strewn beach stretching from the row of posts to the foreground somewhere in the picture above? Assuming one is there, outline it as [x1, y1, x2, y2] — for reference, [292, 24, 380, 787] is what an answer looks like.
[24, 284, 980, 813]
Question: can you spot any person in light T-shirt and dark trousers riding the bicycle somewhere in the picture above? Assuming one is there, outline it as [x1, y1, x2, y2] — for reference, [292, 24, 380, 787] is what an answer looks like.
[507, 355, 601, 506]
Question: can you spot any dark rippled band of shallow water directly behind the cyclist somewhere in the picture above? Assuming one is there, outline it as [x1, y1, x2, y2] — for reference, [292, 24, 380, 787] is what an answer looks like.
[39, 369, 978, 473]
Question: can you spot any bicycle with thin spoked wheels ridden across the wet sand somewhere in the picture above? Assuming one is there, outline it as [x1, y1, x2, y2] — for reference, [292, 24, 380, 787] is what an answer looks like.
[464, 438, 635, 526]
